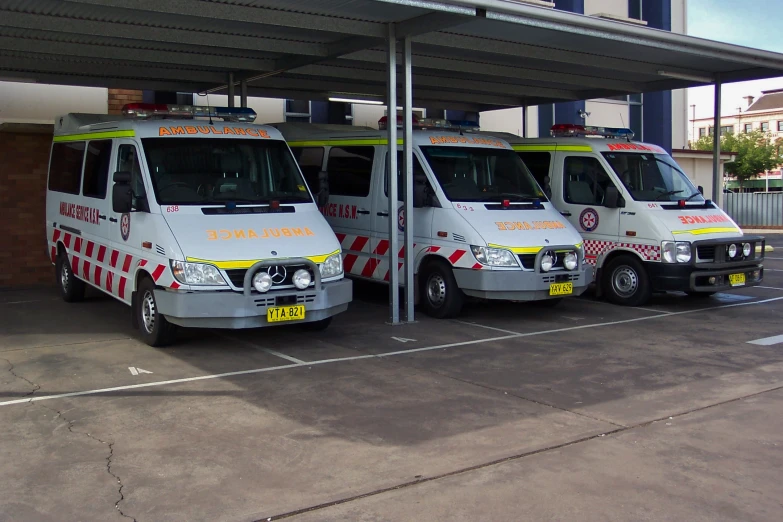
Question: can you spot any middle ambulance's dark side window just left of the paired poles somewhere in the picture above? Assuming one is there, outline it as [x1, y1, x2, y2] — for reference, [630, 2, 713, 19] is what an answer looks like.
[326, 147, 375, 197]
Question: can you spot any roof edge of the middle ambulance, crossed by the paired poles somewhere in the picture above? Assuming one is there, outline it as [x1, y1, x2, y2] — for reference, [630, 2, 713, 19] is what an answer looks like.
[271, 123, 511, 149]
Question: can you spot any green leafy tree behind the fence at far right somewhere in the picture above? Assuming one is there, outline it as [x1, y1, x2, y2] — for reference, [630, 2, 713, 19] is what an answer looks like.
[694, 131, 783, 190]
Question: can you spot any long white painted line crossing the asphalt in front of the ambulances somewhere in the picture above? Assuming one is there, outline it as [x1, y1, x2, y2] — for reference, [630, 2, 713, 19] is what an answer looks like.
[0, 297, 783, 407]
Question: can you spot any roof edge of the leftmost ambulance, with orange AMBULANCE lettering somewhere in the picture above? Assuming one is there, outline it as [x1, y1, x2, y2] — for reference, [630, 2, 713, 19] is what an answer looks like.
[54, 113, 283, 140]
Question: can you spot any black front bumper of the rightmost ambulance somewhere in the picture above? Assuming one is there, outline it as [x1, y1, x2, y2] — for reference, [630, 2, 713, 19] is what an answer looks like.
[646, 263, 764, 292]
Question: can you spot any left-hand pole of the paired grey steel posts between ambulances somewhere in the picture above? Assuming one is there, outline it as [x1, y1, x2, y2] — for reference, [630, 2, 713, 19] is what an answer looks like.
[388, 24, 400, 324]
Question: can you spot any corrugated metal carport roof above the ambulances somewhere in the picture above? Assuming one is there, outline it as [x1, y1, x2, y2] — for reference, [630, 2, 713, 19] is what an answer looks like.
[0, 0, 783, 110]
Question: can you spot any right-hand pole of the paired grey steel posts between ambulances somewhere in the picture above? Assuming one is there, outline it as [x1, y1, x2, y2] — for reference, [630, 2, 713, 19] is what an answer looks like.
[404, 36, 416, 322]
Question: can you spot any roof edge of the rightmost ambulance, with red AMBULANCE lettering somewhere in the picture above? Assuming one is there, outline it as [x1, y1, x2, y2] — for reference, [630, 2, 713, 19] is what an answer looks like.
[484, 132, 667, 154]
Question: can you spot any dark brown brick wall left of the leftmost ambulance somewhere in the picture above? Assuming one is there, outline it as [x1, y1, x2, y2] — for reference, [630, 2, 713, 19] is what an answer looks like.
[0, 125, 54, 288]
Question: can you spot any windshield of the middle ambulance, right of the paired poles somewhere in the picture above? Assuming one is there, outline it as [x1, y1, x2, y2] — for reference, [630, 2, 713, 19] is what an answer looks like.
[421, 147, 546, 201]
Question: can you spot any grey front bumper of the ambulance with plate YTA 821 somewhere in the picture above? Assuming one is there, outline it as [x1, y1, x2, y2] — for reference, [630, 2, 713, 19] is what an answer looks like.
[155, 279, 353, 329]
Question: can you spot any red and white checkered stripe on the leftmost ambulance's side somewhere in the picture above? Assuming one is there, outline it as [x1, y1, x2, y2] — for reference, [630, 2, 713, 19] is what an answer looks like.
[49, 225, 181, 302]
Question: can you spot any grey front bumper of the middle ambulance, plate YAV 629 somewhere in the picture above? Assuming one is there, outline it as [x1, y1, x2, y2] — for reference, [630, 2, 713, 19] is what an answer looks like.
[454, 266, 592, 301]
